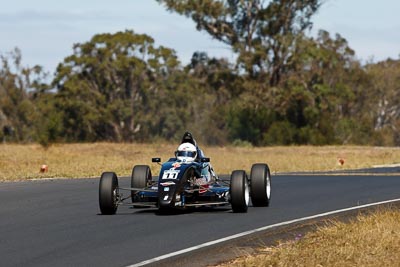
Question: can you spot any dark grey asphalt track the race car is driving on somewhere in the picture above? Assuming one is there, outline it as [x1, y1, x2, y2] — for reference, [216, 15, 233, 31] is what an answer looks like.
[0, 170, 400, 266]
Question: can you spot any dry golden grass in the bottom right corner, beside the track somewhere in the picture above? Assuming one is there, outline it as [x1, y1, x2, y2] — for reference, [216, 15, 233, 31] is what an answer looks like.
[219, 210, 400, 267]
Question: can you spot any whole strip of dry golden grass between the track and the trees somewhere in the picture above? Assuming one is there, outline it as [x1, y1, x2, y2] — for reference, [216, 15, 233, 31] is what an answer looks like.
[0, 143, 400, 181]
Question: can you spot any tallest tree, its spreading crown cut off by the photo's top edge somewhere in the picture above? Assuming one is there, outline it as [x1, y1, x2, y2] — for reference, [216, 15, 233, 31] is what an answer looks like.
[158, 0, 330, 145]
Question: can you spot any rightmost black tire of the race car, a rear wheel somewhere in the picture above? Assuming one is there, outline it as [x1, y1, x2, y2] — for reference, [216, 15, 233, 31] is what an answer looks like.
[250, 163, 271, 207]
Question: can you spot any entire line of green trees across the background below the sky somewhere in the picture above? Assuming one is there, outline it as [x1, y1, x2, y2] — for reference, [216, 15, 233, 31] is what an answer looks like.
[0, 0, 400, 146]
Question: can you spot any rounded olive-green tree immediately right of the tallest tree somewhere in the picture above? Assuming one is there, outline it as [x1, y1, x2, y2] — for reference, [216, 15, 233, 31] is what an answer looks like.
[277, 30, 366, 144]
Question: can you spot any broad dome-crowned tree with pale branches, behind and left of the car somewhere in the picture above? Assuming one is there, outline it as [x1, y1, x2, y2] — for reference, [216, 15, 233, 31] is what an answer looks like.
[53, 31, 183, 141]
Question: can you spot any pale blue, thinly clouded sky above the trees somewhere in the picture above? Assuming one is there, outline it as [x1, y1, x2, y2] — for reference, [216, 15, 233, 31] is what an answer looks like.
[0, 0, 400, 73]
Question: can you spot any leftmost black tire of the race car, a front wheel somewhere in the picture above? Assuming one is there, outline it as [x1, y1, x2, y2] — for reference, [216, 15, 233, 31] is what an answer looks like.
[99, 172, 118, 215]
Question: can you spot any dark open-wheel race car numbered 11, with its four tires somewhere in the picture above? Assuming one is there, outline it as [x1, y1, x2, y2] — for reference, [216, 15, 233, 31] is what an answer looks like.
[99, 157, 271, 215]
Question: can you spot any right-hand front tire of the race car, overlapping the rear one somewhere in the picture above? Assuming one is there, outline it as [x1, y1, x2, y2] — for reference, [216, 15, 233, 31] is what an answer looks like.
[230, 170, 250, 212]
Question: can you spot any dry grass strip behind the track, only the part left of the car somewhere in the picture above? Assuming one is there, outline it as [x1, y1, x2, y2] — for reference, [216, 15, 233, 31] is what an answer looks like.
[0, 143, 170, 181]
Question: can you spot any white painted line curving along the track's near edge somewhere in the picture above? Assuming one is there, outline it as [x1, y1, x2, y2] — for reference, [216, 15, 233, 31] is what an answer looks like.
[126, 198, 400, 267]
